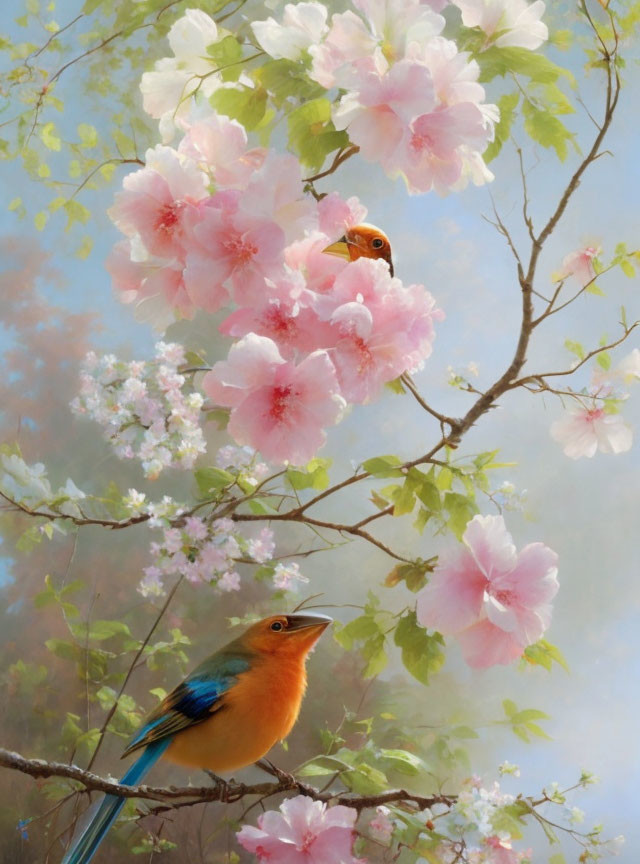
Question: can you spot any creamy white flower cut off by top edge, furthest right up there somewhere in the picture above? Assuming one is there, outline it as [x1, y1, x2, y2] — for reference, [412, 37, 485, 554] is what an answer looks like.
[452, 0, 549, 51]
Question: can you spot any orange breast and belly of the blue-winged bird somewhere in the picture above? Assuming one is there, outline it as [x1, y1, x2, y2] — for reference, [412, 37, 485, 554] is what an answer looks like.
[165, 658, 306, 773]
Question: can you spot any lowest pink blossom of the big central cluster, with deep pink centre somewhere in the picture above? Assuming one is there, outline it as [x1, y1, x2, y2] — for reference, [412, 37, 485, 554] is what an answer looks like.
[203, 333, 344, 464]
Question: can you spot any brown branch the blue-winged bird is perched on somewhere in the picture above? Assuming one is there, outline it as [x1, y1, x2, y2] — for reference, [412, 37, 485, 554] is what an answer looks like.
[0, 748, 456, 811]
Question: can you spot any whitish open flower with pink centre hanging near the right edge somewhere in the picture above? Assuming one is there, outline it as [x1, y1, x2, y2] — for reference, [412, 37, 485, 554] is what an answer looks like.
[551, 401, 633, 459]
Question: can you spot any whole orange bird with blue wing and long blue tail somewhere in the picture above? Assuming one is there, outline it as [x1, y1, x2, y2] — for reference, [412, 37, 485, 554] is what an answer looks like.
[62, 614, 331, 864]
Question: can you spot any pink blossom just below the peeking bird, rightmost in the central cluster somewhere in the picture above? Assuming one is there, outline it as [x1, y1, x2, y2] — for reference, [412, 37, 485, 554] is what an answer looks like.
[330, 258, 442, 402]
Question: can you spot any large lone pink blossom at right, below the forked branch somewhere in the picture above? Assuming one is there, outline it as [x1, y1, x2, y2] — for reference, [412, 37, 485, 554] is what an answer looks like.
[418, 516, 558, 668]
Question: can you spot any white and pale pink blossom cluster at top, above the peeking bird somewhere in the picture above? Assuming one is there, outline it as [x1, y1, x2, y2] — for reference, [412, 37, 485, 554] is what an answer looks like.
[253, 0, 499, 194]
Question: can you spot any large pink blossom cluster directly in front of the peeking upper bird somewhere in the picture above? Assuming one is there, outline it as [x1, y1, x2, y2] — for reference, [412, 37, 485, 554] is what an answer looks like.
[108, 106, 441, 465]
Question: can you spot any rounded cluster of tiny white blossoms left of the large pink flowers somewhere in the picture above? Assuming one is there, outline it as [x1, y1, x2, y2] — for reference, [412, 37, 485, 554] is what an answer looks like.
[71, 342, 206, 478]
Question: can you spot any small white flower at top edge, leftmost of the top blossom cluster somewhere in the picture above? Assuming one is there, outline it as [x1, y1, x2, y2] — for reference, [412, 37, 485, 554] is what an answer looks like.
[251, 3, 327, 60]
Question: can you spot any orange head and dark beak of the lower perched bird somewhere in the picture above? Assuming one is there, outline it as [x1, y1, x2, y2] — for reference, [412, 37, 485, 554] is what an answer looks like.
[244, 612, 332, 657]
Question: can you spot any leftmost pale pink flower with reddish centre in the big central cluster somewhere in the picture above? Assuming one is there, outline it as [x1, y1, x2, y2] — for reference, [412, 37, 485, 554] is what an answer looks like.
[108, 145, 207, 258]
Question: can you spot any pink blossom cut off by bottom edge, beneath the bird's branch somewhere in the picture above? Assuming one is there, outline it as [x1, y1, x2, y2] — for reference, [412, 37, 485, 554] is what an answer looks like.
[236, 795, 358, 864]
